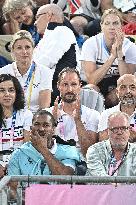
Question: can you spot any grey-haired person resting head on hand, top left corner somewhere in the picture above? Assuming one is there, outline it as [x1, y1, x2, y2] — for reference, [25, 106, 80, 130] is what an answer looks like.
[2, 0, 40, 45]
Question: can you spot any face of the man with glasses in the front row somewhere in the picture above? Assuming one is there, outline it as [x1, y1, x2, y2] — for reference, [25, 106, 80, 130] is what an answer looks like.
[109, 116, 130, 149]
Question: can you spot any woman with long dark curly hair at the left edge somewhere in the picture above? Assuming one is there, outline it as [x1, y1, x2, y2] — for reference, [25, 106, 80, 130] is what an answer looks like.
[0, 74, 32, 175]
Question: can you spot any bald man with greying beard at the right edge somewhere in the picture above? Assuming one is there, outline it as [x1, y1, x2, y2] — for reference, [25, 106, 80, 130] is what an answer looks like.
[98, 74, 136, 142]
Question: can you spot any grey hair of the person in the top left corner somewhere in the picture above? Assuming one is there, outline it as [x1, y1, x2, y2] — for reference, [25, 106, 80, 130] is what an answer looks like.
[2, 0, 36, 20]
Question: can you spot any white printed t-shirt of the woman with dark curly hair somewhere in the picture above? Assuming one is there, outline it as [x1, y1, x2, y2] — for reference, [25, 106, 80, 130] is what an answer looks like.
[0, 109, 33, 166]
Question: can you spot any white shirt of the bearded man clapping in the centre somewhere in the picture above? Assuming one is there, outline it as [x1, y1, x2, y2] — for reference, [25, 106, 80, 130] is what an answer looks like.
[46, 105, 100, 142]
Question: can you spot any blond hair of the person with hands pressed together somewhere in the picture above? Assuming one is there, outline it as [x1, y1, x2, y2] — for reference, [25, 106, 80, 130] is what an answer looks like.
[101, 8, 123, 24]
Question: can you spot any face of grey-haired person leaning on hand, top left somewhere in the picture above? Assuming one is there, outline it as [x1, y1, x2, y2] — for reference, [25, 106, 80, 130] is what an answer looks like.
[11, 6, 33, 25]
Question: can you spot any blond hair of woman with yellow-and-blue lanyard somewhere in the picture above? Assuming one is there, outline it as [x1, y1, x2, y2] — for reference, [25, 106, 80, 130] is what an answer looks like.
[10, 30, 34, 49]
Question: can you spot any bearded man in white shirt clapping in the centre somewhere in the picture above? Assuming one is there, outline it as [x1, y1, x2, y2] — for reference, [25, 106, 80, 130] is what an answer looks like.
[48, 68, 100, 156]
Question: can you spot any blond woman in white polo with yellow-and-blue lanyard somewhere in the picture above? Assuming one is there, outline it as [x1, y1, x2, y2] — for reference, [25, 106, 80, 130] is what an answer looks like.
[0, 30, 52, 112]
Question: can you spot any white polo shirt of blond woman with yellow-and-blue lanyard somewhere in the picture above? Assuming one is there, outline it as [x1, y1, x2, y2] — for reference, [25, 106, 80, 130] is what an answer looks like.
[0, 62, 53, 112]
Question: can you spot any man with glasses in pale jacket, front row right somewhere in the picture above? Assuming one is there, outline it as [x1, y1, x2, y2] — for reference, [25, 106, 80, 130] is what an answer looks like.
[87, 112, 136, 176]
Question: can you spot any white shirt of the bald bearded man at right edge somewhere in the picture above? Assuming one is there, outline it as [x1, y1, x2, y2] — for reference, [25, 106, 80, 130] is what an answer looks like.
[98, 104, 136, 132]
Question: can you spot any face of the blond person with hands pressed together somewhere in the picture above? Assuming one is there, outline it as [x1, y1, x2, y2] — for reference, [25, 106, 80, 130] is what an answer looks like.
[101, 14, 121, 40]
